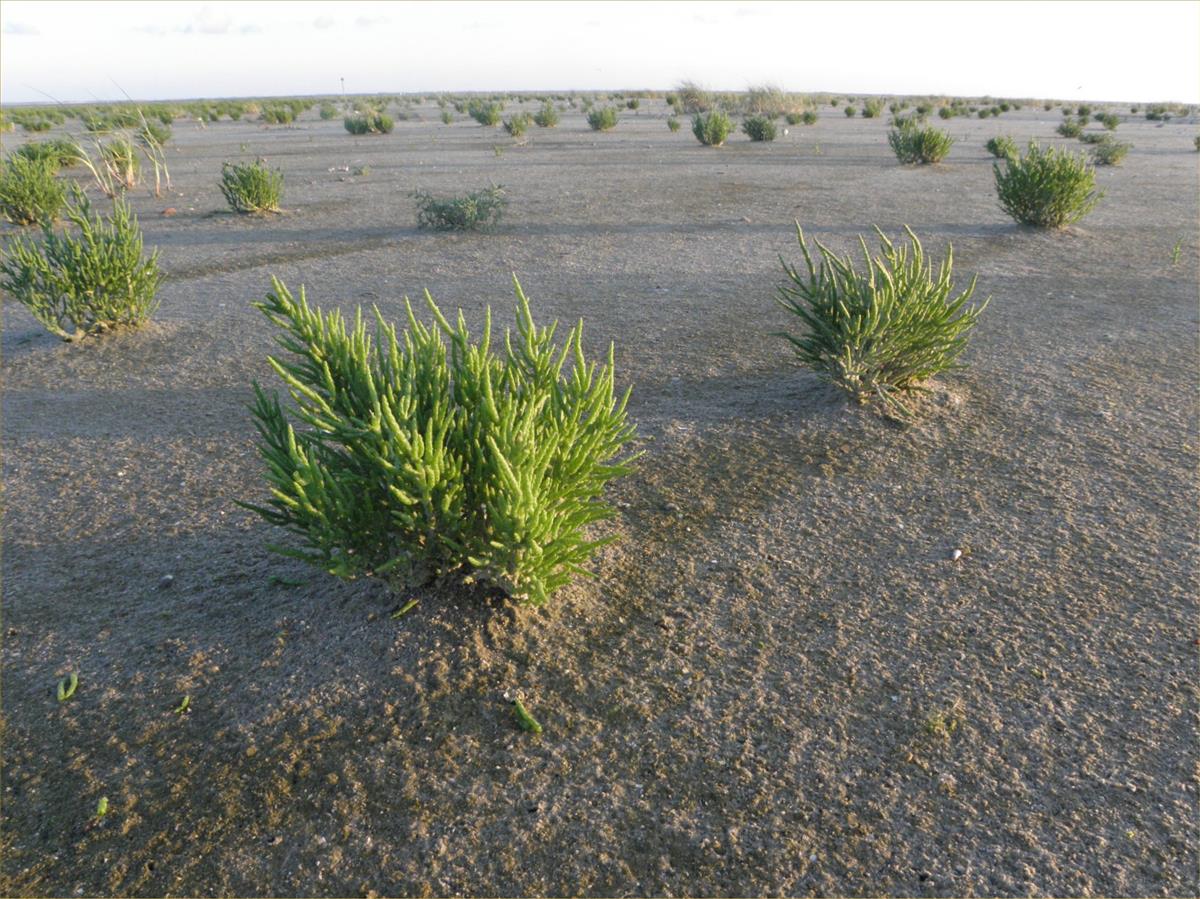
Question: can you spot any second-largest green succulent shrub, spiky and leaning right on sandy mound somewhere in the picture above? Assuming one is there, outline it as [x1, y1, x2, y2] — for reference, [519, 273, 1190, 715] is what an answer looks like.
[776, 226, 988, 412]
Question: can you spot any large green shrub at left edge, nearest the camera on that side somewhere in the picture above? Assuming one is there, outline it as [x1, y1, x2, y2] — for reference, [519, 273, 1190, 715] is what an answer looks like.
[0, 187, 163, 341]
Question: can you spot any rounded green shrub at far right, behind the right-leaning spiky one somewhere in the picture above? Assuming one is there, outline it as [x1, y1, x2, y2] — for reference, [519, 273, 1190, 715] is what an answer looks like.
[992, 142, 1104, 228]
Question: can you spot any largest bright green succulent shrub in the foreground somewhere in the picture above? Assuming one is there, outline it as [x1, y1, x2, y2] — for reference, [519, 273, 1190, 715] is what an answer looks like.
[246, 274, 634, 605]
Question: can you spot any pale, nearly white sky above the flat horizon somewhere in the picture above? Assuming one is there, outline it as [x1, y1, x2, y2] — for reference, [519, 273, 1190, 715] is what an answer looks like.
[0, 0, 1200, 103]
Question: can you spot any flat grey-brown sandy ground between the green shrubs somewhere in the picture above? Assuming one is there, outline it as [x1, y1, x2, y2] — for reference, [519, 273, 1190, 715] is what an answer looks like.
[0, 102, 1200, 895]
